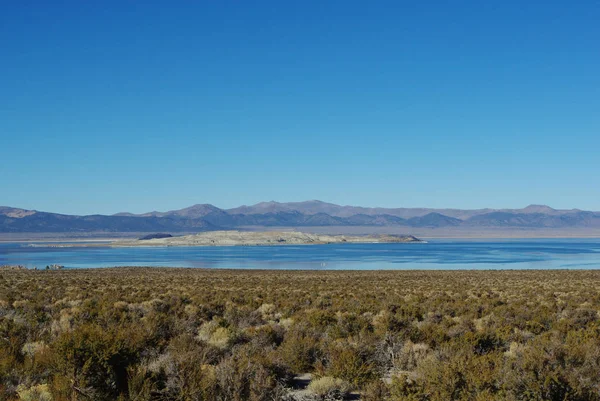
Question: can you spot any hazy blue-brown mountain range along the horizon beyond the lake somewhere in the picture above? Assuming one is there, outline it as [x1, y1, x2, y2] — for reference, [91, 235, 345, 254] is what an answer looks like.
[0, 200, 600, 233]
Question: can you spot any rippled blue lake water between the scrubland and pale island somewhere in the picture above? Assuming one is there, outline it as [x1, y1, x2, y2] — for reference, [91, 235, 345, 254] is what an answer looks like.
[0, 239, 600, 270]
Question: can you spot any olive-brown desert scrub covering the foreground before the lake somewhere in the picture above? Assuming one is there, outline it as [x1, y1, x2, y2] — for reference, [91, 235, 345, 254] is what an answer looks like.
[0, 268, 600, 401]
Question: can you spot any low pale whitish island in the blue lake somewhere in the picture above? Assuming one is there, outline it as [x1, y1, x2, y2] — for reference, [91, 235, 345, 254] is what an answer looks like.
[110, 231, 423, 247]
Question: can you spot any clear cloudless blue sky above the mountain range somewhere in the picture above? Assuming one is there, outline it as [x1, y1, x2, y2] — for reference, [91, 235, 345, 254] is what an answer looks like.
[0, 0, 600, 214]
